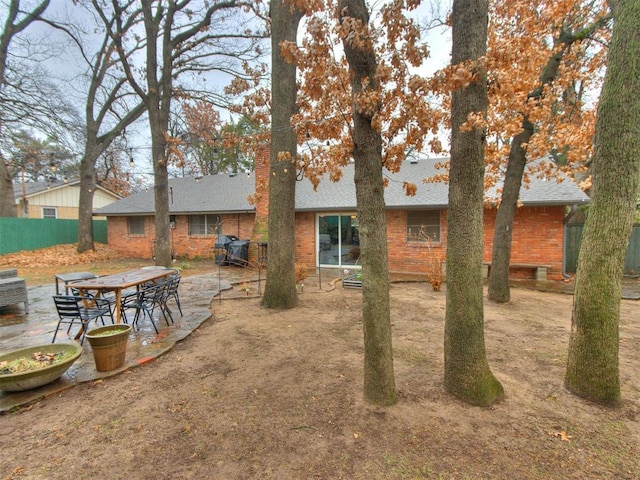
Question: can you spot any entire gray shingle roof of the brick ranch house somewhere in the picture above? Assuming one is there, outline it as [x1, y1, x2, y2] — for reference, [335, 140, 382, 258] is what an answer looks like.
[95, 159, 589, 216]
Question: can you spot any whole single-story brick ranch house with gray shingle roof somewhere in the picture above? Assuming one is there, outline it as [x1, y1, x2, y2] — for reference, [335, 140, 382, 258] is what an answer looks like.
[95, 150, 588, 280]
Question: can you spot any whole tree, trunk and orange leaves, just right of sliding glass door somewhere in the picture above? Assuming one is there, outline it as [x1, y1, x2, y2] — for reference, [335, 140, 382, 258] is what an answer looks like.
[280, 0, 445, 405]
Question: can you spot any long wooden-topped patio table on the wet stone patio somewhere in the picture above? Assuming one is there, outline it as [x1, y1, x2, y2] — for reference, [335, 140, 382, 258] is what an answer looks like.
[70, 267, 174, 323]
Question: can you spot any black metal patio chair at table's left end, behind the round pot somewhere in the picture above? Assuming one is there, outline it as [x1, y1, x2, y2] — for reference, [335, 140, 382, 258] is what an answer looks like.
[51, 295, 113, 344]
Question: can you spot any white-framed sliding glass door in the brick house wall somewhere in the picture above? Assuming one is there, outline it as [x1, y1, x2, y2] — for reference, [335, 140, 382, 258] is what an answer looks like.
[316, 213, 360, 267]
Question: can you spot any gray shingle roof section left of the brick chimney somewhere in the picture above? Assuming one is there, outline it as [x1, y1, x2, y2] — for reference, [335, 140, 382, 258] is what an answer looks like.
[94, 172, 255, 216]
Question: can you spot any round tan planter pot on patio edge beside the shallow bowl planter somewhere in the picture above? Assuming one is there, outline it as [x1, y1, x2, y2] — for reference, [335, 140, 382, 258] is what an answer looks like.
[86, 323, 131, 372]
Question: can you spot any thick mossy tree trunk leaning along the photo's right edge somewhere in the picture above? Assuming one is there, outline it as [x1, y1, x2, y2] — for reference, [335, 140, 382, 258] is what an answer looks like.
[565, 0, 640, 405]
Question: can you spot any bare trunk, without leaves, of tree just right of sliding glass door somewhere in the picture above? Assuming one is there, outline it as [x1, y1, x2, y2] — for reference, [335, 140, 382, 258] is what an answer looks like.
[339, 0, 397, 405]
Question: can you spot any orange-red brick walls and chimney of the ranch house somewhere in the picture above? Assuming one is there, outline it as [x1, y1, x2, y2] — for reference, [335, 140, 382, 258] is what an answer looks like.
[108, 145, 564, 280]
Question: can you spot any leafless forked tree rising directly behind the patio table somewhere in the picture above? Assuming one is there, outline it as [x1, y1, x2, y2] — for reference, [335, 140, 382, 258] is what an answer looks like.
[105, 0, 263, 266]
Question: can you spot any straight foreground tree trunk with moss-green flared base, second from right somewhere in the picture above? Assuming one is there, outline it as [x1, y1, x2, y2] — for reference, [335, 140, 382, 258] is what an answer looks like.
[444, 0, 503, 405]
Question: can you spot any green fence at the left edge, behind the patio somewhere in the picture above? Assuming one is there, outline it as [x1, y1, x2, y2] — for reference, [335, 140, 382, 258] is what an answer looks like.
[0, 218, 107, 255]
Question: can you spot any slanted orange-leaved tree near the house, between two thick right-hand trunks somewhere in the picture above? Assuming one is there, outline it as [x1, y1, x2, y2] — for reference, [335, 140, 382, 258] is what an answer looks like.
[487, 0, 610, 302]
